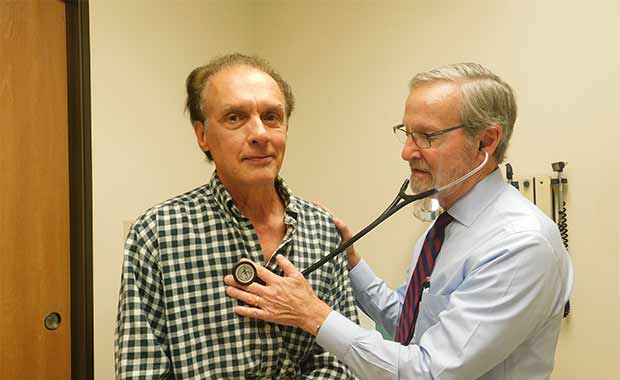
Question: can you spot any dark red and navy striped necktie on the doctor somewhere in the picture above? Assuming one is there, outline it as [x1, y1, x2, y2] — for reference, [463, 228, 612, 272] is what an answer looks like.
[394, 212, 453, 346]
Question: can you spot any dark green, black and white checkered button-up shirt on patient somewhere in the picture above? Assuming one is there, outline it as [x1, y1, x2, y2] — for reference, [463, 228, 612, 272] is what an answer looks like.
[115, 174, 358, 380]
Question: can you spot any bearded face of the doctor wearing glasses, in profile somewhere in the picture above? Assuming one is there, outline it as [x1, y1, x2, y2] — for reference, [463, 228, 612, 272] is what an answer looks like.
[401, 81, 478, 193]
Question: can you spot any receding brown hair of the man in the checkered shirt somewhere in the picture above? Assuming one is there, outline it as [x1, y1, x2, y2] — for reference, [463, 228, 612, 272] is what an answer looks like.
[185, 53, 295, 161]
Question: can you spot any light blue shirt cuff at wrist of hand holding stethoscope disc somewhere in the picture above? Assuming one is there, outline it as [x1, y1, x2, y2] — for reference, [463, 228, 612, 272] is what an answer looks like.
[315, 311, 365, 360]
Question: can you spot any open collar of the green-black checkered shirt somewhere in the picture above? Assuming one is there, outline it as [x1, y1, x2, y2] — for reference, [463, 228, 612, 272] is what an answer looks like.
[207, 171, 299, 224]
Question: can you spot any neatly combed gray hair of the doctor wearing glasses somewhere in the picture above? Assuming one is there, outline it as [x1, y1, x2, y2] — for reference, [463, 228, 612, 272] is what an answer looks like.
[409, 63, 517, 163]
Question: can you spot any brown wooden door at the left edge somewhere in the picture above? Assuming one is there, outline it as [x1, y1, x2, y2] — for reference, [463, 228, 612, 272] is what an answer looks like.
[0, 0, 71, 380]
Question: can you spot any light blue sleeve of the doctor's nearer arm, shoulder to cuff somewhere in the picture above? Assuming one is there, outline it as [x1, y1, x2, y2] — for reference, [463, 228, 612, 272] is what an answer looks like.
[316, 232, 563, 380]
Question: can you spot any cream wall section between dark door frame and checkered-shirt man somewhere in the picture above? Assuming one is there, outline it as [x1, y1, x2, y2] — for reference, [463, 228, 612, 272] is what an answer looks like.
[90, 0, 252, 380]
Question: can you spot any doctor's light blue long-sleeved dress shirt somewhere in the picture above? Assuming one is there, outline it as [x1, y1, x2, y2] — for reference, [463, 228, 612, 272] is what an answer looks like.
[316, 170, 573, 380]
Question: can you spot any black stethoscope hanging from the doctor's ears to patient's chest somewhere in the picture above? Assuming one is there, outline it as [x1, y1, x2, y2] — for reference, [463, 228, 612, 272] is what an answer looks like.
[233, 151, 489, 286]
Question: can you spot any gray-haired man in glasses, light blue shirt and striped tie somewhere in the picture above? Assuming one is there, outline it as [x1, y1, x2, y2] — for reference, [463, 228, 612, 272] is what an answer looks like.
[224, 63, 573, 380]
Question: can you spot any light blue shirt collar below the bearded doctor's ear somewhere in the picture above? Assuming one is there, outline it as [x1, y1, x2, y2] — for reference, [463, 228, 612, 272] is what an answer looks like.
[448, 168, 506, 227]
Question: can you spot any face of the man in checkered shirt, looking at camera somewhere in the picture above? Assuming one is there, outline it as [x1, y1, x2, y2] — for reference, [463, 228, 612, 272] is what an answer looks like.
[199, 66, 288, 191]
